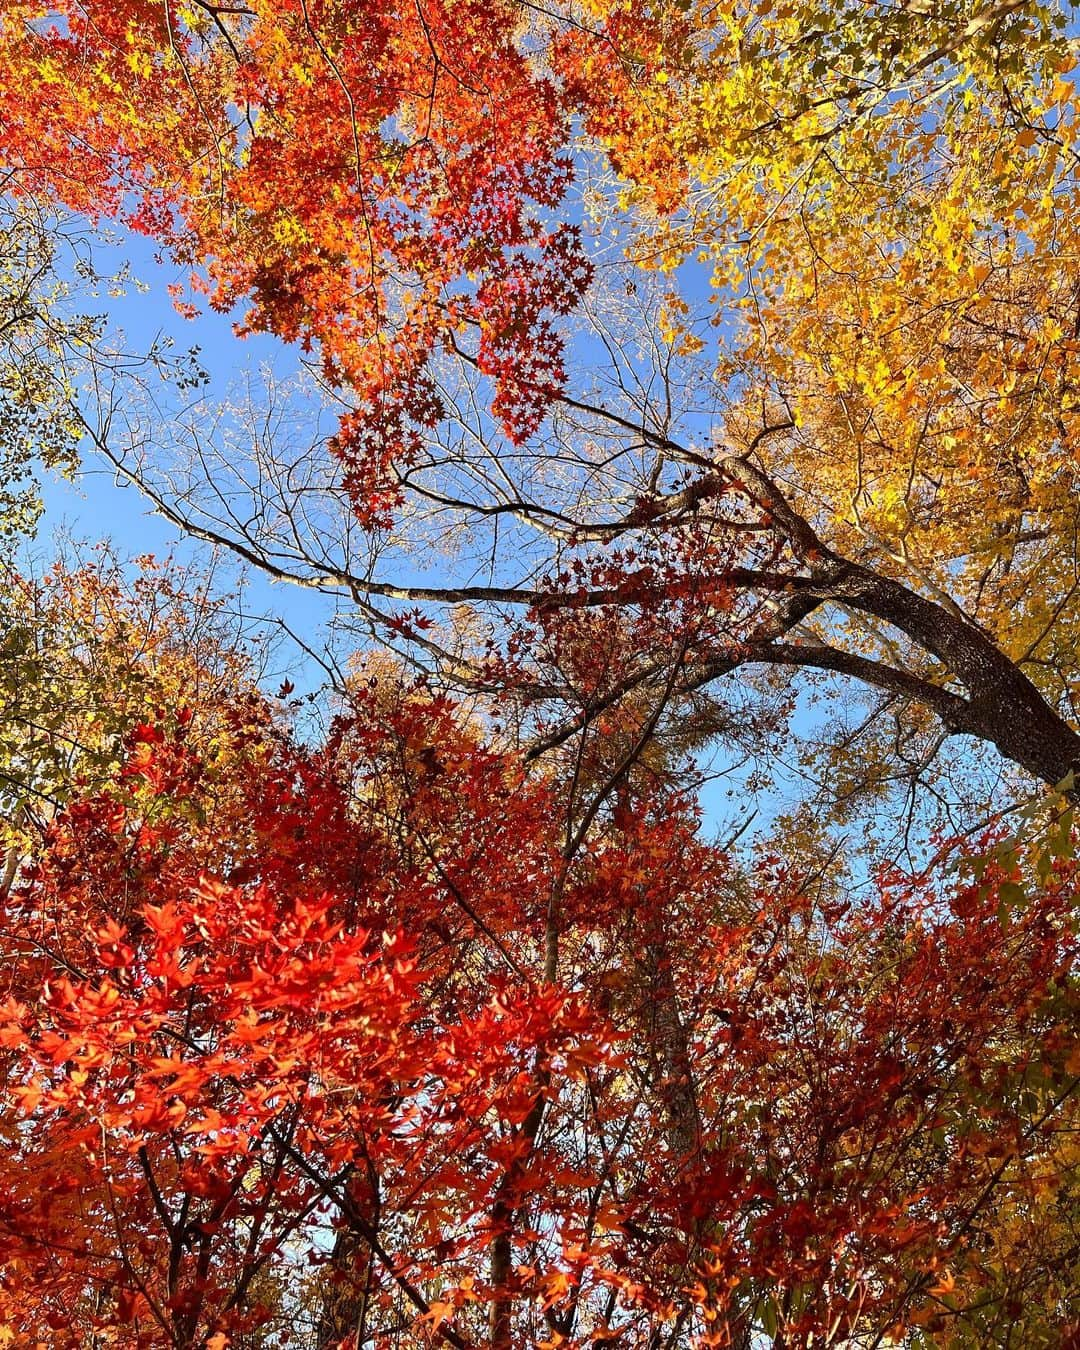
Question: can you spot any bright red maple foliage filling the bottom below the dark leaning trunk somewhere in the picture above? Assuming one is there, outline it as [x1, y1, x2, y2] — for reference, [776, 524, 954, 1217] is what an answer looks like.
[0, 648, 1077, 1346]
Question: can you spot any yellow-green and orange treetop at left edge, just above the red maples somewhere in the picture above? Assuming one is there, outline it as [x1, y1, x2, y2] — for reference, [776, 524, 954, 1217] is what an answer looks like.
[0, 548, 255, 891]
